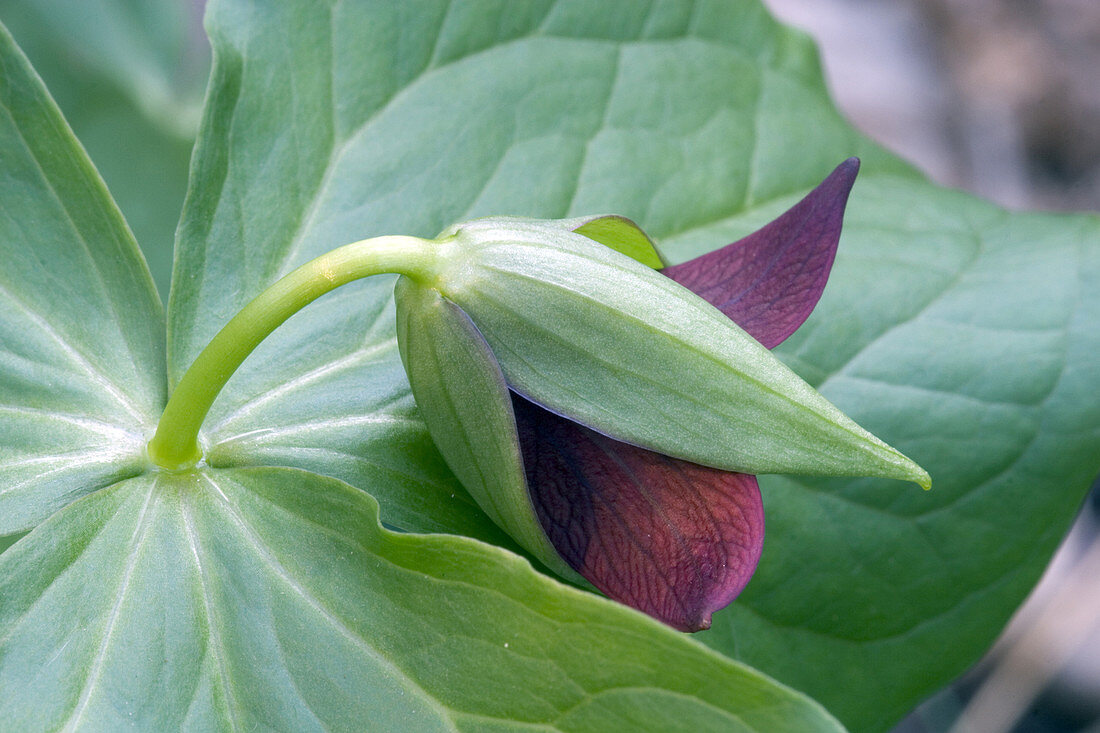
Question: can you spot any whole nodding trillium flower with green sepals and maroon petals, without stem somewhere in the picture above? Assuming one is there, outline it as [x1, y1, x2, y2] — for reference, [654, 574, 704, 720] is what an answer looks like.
[396, 158, 927, 631]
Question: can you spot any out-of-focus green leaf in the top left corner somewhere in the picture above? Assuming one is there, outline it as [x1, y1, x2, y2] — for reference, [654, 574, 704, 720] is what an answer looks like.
[0, 0, 210, 297]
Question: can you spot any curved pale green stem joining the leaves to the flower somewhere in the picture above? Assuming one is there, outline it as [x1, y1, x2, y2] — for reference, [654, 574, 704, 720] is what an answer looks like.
[147, 237, 439, 470]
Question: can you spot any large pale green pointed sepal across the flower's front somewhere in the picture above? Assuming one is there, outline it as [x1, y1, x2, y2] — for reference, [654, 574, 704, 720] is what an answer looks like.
[438, 219, 930, 488]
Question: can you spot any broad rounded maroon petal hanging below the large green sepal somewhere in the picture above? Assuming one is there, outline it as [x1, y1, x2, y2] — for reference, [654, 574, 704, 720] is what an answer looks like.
[513, 393, 763, 631]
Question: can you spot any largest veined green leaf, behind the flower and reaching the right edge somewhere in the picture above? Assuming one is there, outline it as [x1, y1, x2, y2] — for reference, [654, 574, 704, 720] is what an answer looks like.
[169, 0, 1100, 730]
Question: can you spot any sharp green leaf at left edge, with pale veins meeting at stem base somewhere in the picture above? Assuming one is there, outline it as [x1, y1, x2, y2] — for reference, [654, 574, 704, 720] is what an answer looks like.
[0, 28, 165, 535]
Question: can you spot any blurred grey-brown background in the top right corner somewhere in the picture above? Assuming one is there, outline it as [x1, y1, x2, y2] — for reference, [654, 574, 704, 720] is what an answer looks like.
[765, 0, 1100, 211]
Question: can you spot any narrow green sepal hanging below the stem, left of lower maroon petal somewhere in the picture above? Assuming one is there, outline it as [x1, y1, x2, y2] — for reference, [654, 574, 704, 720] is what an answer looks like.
[394, 277, 587, 584]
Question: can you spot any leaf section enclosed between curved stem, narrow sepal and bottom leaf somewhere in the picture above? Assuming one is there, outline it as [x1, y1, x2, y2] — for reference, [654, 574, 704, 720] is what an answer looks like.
[195, 277, 508, 545]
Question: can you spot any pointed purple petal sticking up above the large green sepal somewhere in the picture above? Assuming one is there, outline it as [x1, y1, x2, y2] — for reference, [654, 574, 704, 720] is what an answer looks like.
[661, 157, 859, 349]
